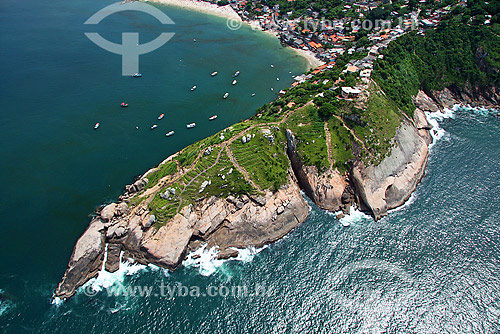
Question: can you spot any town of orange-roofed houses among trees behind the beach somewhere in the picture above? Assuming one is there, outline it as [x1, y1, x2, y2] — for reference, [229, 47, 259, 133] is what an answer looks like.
[219, 0, 460, 88]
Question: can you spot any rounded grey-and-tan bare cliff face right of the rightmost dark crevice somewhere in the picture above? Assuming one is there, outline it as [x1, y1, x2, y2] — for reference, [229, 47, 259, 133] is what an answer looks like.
[352, 118, 429, 219]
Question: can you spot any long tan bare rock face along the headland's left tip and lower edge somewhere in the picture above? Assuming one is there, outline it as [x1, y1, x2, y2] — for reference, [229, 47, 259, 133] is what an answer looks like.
[51, 171, 309, 298]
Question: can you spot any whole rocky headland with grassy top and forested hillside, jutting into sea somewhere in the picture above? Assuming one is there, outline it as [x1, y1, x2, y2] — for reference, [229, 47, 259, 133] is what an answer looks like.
[55, 3, 500, 298]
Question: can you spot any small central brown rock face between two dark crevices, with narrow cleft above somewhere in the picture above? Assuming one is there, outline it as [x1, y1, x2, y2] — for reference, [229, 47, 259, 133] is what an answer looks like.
[286, 130, 348, 211]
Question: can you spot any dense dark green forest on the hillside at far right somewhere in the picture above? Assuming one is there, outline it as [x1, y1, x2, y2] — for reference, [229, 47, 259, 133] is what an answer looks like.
[372, 8, 500, 116]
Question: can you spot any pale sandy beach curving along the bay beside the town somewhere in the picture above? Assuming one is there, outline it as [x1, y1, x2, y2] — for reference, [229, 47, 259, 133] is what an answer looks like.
[143, 0, 325, 72]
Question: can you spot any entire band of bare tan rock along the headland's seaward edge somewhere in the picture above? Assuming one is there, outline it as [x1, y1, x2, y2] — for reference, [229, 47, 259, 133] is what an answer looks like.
[55, 85, 472, 298]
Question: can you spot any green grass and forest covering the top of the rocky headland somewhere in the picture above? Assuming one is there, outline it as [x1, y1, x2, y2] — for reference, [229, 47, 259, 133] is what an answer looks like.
[131, 14, 500, 224]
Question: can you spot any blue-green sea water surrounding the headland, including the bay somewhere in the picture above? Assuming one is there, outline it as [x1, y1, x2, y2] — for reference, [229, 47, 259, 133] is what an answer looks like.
[0, 0, 500, 333]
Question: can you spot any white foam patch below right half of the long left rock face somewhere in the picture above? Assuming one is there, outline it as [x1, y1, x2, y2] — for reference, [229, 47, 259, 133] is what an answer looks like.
[182, 244, 267, 276]
